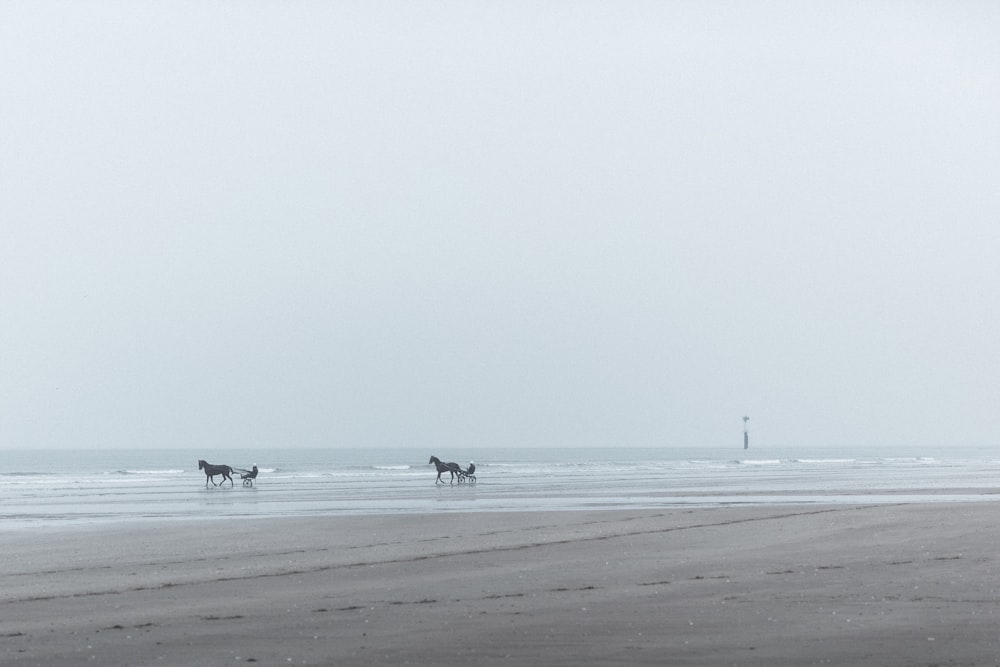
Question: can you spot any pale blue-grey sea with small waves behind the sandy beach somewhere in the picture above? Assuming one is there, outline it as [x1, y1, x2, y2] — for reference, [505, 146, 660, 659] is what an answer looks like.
[0, 448, 1000, 529]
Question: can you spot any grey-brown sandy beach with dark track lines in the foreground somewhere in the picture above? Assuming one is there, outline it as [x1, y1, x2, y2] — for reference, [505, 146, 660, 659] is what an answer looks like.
[0, 502, 1000, 665]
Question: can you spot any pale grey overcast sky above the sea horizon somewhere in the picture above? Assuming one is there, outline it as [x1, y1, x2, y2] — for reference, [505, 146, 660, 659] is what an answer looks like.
[0, 0, 1000, 448]
